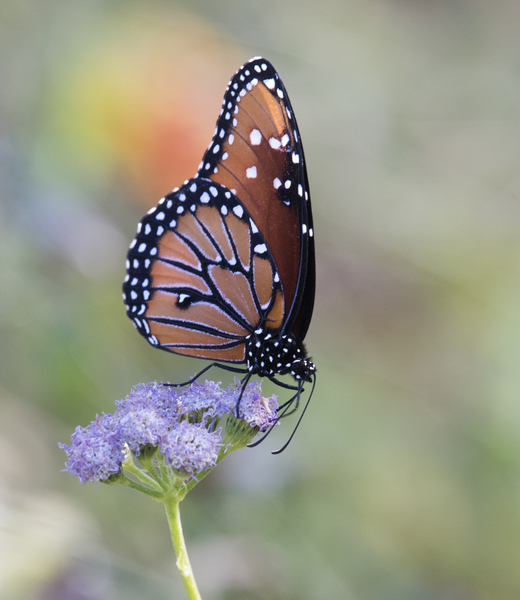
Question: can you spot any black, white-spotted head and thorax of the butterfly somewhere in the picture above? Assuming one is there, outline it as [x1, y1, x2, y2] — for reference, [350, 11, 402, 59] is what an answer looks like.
[246, 329, 316, 381]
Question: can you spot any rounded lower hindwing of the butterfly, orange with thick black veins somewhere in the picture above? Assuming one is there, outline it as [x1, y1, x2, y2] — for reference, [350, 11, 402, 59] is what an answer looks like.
[123, 178, 284, 362]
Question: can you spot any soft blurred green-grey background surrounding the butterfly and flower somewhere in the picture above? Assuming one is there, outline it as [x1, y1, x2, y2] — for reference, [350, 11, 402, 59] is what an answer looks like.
[0, 0, 520, 600]
